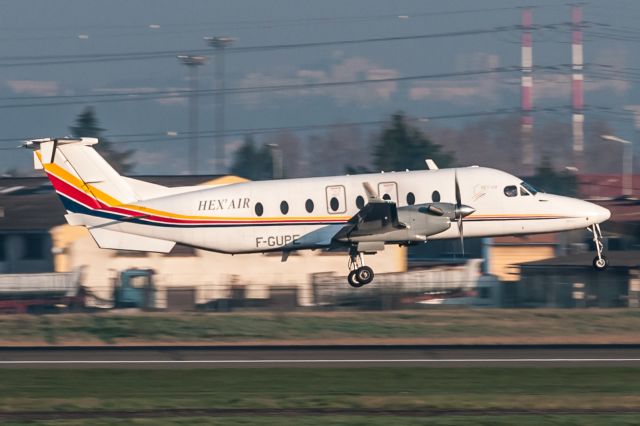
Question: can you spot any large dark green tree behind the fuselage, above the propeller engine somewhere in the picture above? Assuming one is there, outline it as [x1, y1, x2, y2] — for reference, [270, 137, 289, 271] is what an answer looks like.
[373, 113, 453, 170]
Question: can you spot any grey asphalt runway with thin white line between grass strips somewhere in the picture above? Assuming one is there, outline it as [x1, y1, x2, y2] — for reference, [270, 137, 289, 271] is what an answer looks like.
[0, 345, 640, 369]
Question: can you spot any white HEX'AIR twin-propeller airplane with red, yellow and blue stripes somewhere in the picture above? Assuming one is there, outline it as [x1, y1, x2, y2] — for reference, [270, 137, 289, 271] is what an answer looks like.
[24, 138, 611, 287]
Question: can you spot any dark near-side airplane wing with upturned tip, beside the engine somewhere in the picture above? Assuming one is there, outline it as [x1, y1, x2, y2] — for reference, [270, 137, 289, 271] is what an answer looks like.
[333, 182, 407, 240]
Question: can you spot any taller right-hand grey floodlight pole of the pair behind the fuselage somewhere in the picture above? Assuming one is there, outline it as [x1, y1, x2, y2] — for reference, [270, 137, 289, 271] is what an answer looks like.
[205, 37, 234, 174]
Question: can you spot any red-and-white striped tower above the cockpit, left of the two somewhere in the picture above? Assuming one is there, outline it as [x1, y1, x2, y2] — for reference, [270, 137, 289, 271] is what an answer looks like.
[520, 8, 534, 174]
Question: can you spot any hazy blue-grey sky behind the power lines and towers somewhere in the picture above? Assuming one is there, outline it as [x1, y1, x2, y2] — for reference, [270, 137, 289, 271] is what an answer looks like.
[0, 0, 640, 173]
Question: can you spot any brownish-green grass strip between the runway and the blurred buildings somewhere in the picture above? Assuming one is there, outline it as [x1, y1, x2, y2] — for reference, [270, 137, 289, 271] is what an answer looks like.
[0, 309, 640, 345]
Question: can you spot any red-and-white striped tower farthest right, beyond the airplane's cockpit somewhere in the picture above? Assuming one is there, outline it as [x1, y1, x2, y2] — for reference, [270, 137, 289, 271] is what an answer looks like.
[571, 4, 584, 170]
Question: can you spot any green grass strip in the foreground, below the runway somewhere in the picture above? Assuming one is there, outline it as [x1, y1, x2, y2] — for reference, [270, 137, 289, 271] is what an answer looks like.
[0, 368, 640, 425]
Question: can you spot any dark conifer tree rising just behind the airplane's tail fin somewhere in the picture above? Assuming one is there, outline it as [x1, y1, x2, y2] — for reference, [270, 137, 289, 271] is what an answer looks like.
[69, 107, 135, 174]
